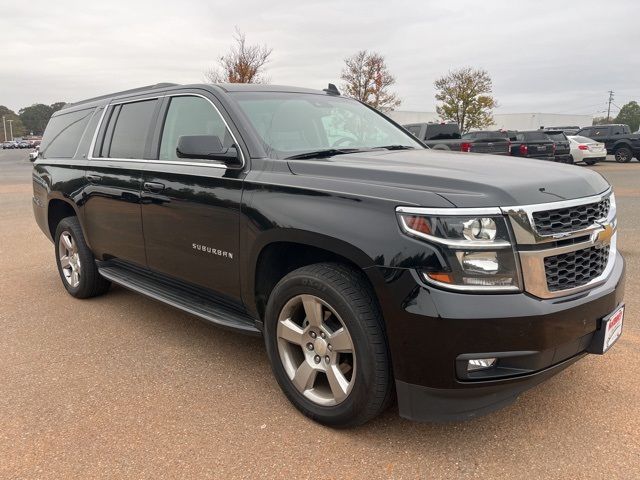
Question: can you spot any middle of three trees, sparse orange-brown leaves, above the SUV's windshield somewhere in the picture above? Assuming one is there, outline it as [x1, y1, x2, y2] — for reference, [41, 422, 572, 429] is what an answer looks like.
[340, 50, 401, 112]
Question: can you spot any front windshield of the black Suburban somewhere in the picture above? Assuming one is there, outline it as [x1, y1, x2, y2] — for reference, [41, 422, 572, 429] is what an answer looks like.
[232, 92, 423, 158]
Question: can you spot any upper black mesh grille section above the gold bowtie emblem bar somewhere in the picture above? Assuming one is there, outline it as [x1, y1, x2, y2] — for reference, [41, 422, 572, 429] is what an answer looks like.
[533, 198, 610, 235]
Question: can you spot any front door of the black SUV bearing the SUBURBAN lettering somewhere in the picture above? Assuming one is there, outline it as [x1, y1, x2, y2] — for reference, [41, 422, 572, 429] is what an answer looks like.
[142, 92, 245, 301]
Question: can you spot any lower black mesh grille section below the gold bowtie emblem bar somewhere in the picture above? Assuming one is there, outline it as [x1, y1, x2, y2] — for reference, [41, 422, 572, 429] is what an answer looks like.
[544, 245, 609, 292]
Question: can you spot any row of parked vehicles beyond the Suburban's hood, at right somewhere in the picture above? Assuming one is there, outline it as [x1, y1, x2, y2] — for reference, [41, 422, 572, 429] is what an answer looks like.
[404, 123, 640, 165]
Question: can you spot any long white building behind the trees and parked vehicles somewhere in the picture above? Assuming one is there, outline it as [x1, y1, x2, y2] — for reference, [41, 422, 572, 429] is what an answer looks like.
[388, 110, 593, 130]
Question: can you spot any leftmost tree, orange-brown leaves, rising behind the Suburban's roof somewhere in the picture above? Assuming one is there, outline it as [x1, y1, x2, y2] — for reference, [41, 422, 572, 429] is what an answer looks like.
[205, 27, 273, 83]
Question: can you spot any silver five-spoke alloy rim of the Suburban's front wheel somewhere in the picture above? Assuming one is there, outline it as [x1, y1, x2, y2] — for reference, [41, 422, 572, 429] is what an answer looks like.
[277, 295, 356, 406]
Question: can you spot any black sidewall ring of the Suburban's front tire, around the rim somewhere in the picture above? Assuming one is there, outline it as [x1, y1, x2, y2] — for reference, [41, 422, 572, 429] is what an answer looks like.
[264, 273, 375, 426]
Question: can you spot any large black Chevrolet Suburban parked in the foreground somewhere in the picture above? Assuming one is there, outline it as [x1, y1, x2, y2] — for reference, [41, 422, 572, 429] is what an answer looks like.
[33, 84, 624, 427]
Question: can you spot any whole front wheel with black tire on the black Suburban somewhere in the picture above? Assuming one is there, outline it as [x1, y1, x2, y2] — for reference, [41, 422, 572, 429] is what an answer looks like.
[264, 263, 393, 428]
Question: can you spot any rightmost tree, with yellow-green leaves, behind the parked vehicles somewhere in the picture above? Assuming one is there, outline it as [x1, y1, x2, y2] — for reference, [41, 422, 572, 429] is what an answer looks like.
[434, 67, 498, 133]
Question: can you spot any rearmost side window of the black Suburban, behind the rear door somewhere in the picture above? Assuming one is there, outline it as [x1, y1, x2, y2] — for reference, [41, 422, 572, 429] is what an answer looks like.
[40, 108, 95, 158]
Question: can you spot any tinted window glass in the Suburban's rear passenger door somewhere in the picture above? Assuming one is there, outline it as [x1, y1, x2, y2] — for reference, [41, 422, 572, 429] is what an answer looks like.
[103, 100, 157, 158]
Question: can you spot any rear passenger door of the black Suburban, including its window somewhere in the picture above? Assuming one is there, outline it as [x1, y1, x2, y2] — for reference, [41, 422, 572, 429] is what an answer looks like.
[84, 98, 160, 266]
